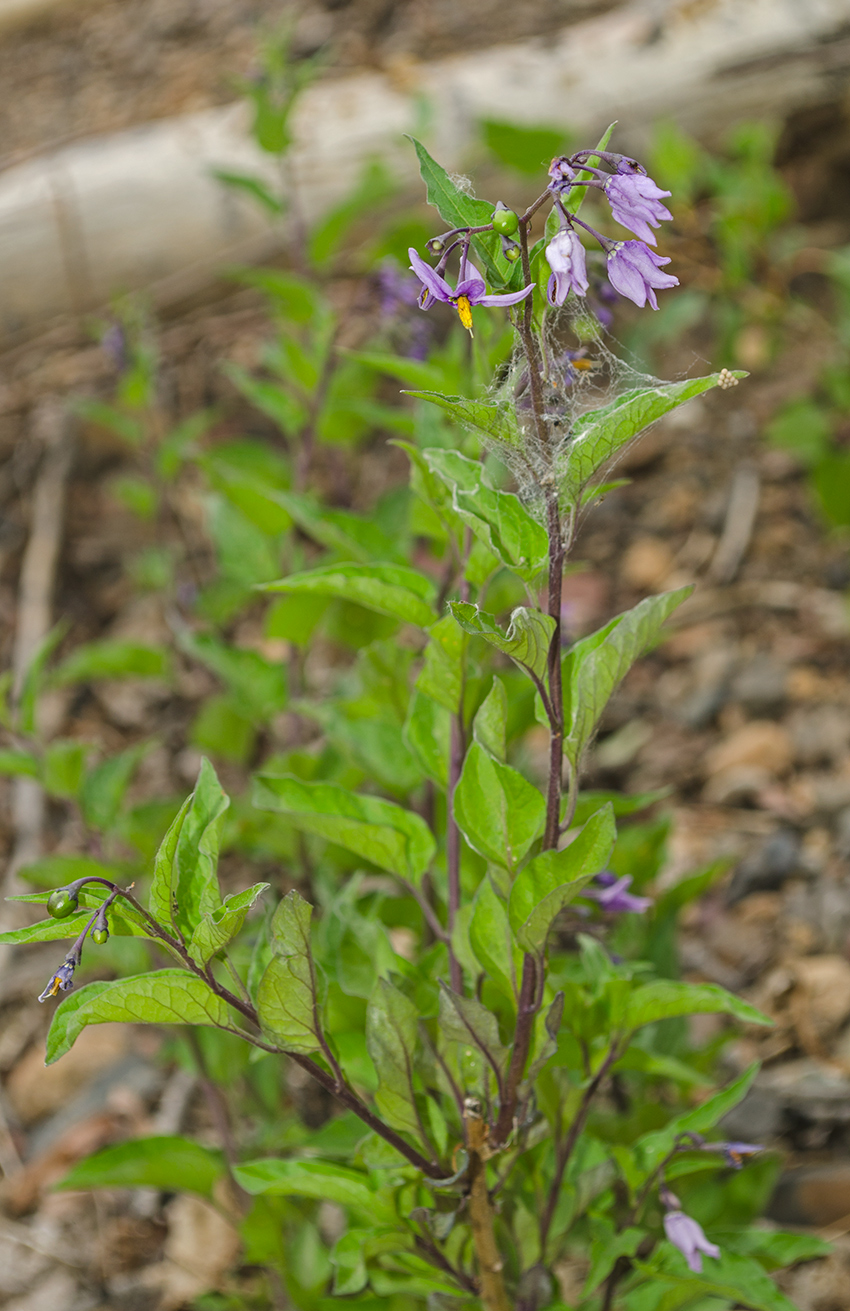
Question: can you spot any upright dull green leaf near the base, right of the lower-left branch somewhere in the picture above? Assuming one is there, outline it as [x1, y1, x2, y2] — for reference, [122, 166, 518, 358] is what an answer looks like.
[366, 978, 424, 1143]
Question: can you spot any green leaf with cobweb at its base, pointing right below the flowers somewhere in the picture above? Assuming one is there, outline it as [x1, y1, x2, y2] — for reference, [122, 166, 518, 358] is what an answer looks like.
[561, 380, 746, 503]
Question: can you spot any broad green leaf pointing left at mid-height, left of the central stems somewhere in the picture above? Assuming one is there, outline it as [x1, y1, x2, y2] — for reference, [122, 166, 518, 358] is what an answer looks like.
[254, 773, 435, 882]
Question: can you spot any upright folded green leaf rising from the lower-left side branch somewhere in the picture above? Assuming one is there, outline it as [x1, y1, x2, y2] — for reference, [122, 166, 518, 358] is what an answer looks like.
[150, 760, 230, 941]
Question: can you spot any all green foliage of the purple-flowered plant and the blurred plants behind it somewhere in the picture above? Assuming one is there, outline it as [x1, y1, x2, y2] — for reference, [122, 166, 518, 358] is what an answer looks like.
[6, 87, 818, 1311]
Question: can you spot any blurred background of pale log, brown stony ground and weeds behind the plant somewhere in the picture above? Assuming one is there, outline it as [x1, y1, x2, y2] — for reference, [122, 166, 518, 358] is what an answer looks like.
[0, 0, 850, 1311]
